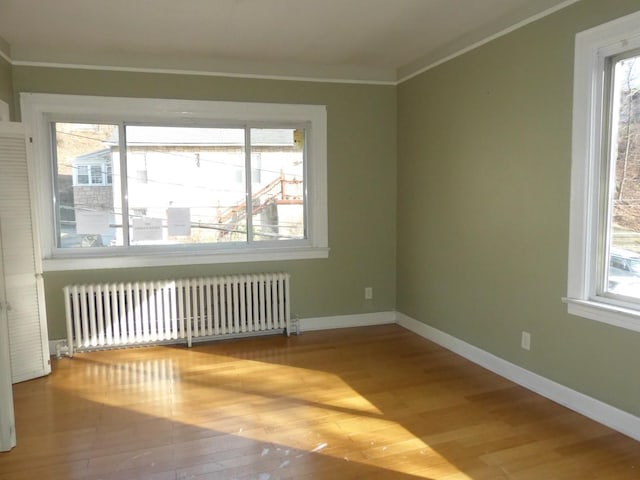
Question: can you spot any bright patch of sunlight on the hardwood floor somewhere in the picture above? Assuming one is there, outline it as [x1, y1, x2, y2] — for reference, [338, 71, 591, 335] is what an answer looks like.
[56, 350, 471, 480]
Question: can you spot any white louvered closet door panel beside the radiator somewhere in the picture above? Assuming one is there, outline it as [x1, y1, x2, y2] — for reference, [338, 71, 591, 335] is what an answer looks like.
[0, 122, 51, 383]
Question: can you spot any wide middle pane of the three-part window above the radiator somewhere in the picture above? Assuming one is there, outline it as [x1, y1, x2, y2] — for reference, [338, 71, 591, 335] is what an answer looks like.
[126, 126, 247, 245]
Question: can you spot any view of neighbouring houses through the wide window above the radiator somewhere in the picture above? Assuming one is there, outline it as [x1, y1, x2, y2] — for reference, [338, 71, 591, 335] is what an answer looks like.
[52, 122, 307, 249]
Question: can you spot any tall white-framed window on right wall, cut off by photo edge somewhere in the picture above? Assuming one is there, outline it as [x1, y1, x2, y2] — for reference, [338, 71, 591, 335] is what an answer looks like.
[567, 12, 640, 331]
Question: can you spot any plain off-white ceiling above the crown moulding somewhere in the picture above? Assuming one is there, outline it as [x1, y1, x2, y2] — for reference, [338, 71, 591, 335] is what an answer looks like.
[0, 0, 578, 83]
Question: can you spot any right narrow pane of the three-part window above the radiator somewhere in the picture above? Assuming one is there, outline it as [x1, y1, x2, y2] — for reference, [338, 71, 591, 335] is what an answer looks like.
[251, 128, 306, 241]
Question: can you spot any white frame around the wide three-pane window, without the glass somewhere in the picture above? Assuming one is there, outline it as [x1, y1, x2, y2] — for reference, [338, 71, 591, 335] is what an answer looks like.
[20, 93, 329, 271]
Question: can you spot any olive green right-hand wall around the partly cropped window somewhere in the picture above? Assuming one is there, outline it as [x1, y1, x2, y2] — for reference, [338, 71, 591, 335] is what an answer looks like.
[397, 0, 640, 415]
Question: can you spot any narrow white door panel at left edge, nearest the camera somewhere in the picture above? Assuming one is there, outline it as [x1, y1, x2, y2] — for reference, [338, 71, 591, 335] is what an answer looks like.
[0, 219, 16, 452]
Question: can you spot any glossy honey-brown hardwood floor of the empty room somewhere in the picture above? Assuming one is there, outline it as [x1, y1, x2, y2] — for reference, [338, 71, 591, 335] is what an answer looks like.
[0, 325, 640, 480]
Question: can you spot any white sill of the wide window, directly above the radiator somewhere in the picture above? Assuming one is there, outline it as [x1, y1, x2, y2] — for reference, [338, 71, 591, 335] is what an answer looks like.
[42, 247, 329, 272]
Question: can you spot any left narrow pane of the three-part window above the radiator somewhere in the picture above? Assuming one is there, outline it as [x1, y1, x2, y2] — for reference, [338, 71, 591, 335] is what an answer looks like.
[53, 123, 122, 248]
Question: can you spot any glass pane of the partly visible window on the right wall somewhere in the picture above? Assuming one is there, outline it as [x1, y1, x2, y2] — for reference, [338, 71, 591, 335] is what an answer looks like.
[607, 56, 640, 299]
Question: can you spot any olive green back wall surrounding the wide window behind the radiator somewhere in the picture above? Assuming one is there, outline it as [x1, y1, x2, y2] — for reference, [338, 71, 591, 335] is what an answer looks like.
[13, 66, 396, 339]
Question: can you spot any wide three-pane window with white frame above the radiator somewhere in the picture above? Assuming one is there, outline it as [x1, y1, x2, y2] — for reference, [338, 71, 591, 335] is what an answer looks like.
[22, 94, 327, 269]
